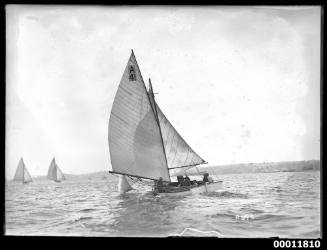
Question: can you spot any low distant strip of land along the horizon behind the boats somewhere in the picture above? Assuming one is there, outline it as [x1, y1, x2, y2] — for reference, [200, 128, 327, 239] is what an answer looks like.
[28, 160, 320, 181]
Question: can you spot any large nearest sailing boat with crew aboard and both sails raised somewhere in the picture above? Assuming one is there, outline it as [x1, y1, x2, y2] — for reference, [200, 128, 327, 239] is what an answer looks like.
[108, 50, 222, 194]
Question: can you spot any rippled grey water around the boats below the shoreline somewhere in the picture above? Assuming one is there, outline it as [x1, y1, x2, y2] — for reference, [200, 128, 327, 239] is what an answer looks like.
[5, 171, 320, 238]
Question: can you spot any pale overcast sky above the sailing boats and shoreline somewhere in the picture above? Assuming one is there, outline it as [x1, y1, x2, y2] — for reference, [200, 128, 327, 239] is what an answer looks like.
[5, 5, 321, 179]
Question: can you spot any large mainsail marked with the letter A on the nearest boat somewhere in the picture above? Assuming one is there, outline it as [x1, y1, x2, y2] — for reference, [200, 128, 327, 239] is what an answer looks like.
[108, 51, 170, 181]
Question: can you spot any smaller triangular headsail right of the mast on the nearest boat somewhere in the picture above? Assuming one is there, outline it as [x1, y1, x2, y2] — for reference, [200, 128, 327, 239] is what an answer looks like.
[148, 80, 206, 175]
